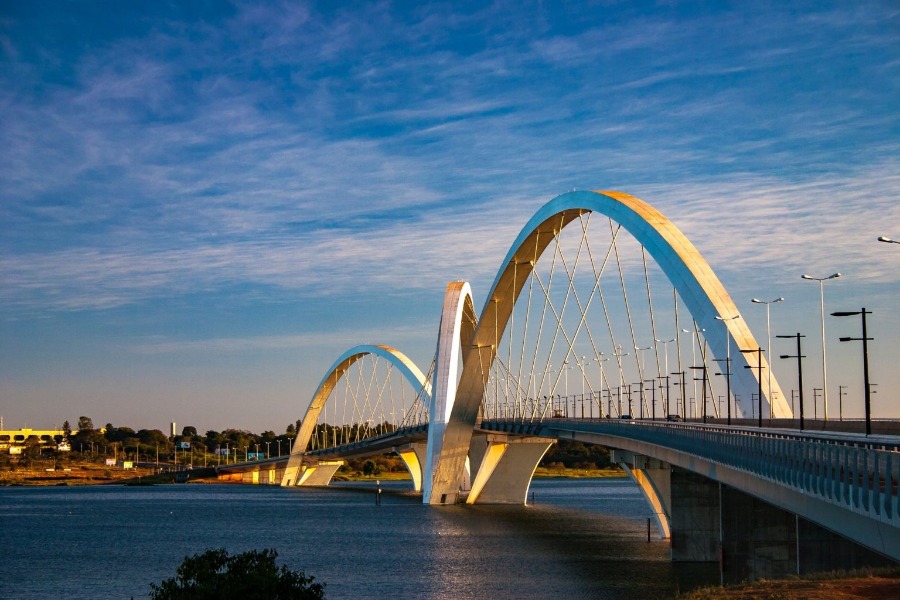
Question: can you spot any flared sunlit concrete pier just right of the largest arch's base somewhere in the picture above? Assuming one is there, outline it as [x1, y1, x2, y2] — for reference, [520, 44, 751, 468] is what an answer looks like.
[466, 434, 556, 504]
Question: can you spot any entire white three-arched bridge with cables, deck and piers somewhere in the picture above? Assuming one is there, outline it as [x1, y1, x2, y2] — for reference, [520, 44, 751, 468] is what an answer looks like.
[214, 191, 900, 579]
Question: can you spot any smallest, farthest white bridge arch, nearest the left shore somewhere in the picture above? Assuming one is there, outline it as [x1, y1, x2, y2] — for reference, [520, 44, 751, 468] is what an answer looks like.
[282, 344, 432, 485]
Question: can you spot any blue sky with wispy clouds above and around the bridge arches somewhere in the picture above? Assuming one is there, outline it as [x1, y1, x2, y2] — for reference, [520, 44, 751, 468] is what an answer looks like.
[0, 0, 900, 432]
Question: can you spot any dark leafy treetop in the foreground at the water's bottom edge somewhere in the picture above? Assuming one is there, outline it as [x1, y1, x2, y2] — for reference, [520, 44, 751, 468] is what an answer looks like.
[150, 548, 325, 600]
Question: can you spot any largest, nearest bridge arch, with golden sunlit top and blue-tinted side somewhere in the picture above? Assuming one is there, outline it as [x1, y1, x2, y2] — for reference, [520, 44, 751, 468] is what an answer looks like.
[431, 191, 791, 503]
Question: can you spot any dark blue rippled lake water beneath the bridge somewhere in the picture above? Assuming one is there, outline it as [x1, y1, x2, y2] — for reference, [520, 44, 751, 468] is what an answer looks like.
[0, 479, 718, 600]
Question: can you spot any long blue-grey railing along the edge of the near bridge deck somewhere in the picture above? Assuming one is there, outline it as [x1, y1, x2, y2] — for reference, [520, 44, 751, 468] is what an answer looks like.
[481, 419, 900, 526]
